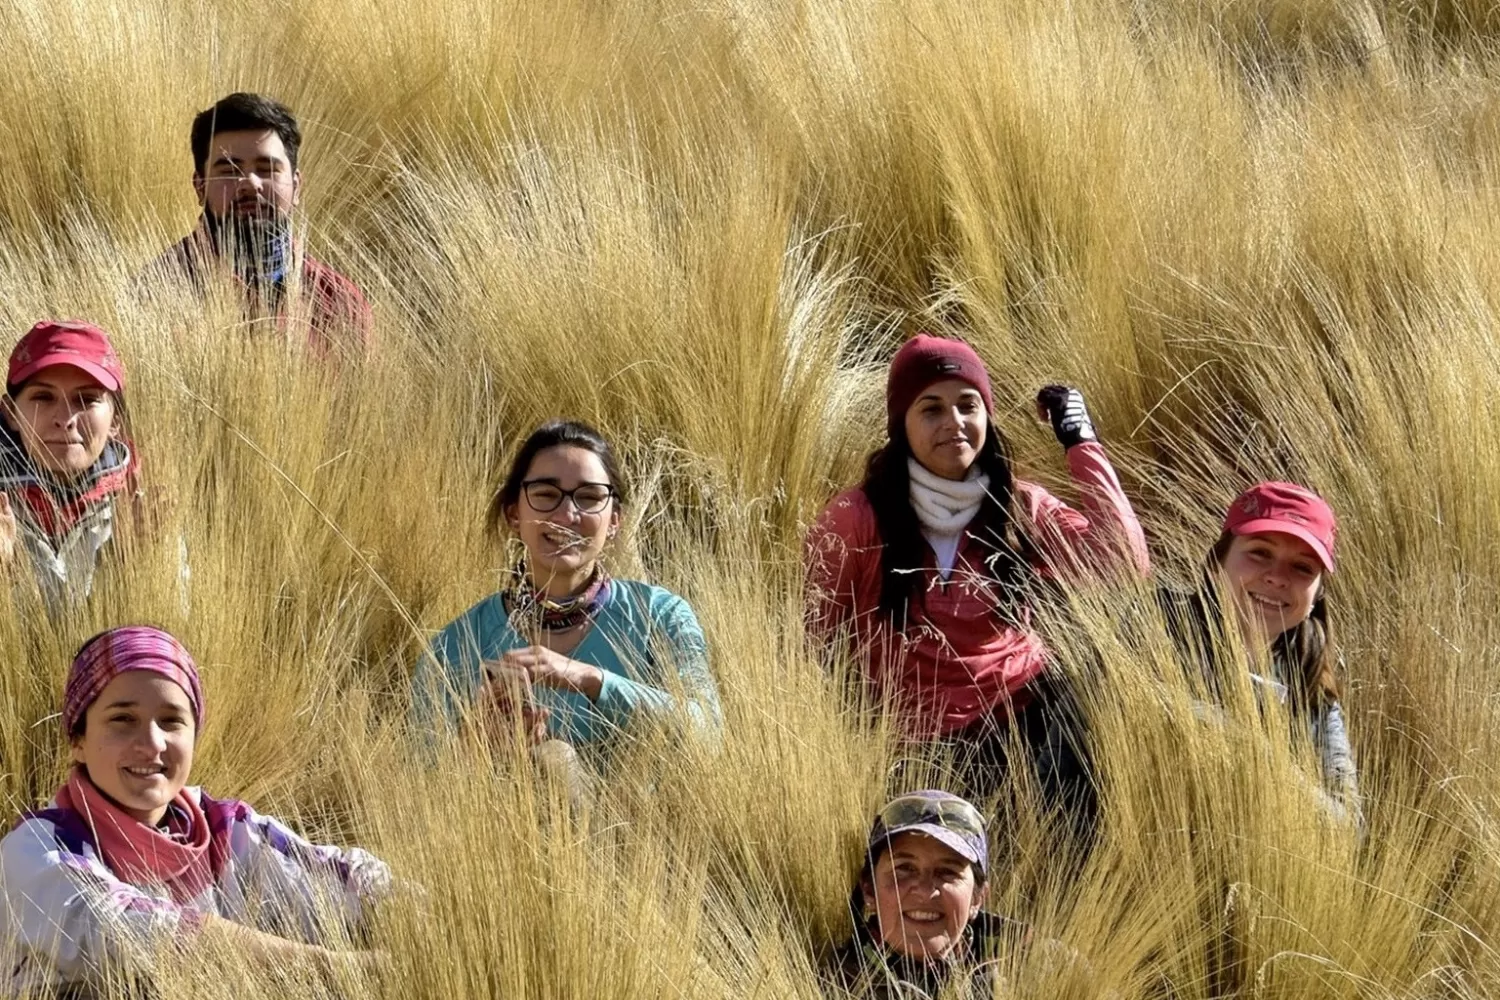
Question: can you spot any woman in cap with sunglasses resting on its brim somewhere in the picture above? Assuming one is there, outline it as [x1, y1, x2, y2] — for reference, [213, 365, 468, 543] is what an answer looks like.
[831, 790, 1025, 999]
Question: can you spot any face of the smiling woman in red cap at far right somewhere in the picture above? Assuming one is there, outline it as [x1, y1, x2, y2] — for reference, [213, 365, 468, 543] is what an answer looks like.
[1223, 531, 1323, 645]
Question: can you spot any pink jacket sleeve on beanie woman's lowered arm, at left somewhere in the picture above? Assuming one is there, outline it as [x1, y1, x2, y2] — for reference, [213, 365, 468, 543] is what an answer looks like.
[804, 489, 881, 637]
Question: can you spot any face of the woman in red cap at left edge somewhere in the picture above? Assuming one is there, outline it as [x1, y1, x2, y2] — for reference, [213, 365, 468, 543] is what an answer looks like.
[5, 364, 120, 478]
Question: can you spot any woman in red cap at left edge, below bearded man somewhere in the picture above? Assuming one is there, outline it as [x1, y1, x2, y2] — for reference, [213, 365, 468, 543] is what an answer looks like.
[0, 321, 137, 613]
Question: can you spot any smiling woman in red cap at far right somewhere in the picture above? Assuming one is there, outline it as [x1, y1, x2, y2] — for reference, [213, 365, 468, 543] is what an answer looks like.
[1163, 483, 1359, 822]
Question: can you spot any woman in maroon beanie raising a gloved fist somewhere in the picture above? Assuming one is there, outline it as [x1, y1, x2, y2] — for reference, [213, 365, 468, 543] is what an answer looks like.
[807, 336, 1149, 798]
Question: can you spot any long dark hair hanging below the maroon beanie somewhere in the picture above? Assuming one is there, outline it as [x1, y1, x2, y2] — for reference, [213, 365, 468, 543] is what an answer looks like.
[860, 420, 1037, 627]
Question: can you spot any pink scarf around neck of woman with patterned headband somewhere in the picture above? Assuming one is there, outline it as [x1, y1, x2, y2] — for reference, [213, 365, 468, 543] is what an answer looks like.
[57, 768, 228, 904]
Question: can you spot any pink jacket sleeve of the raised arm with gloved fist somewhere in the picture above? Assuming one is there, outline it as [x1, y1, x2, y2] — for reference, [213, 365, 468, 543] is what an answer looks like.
[1016, 442, 1151, 579]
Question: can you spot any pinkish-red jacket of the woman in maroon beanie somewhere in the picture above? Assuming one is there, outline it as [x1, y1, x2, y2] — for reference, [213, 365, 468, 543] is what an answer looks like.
[806, 442, 1151, 739]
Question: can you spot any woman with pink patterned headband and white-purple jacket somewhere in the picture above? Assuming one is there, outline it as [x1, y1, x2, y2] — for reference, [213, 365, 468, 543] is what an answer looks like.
[0, 625, 390, 996]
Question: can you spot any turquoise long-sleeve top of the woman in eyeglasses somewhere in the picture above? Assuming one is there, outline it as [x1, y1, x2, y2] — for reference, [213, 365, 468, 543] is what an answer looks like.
[413, 580, 720, 745]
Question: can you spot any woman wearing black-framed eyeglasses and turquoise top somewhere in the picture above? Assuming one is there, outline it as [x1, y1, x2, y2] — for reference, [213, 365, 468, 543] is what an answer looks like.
[416, 420, 720, 760]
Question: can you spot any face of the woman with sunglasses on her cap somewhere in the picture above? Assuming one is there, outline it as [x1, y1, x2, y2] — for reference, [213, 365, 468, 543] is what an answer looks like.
[866, 834, 987, 958]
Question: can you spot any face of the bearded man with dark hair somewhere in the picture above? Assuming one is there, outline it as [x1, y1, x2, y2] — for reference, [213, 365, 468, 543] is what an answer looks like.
[192, 129, 302, 219]
